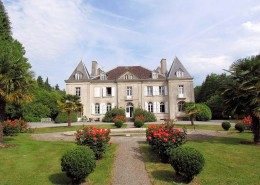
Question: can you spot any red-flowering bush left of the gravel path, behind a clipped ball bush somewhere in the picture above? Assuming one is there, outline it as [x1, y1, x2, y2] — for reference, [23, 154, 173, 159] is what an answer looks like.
[76, 126, 110, 159]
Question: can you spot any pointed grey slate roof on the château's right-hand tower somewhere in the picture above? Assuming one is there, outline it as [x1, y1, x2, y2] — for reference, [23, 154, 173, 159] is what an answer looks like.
[167, 57, 192, 79]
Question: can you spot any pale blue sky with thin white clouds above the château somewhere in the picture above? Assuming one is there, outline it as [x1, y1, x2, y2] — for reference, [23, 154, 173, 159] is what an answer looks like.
[3, 0, 260, 88]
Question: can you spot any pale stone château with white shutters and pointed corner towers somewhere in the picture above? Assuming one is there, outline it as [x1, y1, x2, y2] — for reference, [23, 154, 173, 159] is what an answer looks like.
[65, 57, 194, 120]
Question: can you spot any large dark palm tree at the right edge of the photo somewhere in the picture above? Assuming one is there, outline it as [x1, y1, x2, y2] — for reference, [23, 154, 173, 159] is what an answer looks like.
[222, 55, 260, 143]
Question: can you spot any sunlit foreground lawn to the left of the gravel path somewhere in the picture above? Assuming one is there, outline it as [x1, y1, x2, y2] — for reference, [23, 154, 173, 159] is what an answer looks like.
[0, 134, 117, 185]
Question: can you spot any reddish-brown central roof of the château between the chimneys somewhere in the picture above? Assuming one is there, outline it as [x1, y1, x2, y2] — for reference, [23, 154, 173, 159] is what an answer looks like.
[106, 66, 163, 80]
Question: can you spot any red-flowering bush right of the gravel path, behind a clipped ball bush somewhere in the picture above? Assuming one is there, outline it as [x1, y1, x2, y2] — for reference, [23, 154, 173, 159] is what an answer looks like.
[146, 124, 186, 162]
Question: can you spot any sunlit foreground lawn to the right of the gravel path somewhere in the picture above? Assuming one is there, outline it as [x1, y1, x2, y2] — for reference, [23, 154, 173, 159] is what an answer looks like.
[141, 132, 260, 185]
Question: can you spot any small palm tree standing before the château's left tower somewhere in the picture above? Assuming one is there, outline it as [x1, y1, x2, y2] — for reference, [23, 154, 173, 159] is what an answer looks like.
[59, 95, 82, 127]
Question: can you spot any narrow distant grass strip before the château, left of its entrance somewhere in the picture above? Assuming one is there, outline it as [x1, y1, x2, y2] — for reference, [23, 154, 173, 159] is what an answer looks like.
[33, 124, 126, 134]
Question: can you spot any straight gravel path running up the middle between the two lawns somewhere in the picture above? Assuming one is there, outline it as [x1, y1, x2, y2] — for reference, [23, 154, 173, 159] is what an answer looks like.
[111, 136, 151, 185]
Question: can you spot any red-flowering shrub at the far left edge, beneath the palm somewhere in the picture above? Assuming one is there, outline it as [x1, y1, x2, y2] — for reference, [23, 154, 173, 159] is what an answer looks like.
[3, 119, 29, 136]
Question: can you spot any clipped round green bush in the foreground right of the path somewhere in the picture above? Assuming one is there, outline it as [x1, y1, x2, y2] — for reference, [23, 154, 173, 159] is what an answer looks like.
[170, 147, 205, 182]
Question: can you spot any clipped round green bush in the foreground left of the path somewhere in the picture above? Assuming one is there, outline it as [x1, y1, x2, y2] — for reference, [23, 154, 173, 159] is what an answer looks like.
[61, 146, 96, 183]
